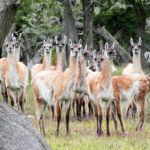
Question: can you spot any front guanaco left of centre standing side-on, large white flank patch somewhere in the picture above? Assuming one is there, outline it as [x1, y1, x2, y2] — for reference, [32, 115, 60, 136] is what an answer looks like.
[32, 40, 81, 136]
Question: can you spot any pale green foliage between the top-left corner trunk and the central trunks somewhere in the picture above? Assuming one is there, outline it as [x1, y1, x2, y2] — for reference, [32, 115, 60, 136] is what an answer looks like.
[15, 0, 62, 57]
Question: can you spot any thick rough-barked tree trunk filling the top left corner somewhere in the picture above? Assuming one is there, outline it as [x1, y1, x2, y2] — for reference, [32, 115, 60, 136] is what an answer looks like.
[0, 0, 21, 48]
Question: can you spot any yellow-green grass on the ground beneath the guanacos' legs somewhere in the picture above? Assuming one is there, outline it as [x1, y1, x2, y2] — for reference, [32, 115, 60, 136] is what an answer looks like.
[2, 67, 150, 150]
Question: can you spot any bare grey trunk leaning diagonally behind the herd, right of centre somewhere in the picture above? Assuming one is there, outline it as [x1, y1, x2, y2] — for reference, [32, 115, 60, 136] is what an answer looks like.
[94, 27, 131, 63]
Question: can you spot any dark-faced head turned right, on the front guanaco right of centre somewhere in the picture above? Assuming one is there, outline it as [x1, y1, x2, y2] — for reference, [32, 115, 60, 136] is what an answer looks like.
[104, 42, 117, 60]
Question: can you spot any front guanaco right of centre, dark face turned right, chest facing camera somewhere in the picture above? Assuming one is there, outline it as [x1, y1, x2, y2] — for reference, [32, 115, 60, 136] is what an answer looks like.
[87, 43, 116, 136]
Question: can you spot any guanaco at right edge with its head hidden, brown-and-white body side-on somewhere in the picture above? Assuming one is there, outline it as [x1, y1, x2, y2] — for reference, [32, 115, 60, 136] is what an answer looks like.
[108, 74, 150, 134]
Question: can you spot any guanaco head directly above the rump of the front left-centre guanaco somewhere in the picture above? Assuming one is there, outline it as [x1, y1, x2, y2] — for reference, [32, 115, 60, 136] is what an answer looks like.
[43, 39, 53, 54]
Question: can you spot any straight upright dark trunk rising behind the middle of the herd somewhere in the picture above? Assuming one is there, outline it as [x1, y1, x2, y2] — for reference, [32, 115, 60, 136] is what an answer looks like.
[82, 0, 93, 49]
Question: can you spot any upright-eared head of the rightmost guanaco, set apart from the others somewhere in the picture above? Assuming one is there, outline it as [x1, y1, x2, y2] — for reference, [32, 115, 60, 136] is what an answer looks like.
[130, 37, 142, 55]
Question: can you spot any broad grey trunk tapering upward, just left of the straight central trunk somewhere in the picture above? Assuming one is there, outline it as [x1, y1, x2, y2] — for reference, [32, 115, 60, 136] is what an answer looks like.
[62, 0, 78, 68]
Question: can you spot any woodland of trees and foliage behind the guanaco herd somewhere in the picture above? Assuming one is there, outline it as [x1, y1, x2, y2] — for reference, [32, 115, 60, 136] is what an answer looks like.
[1, 0, 150, 68]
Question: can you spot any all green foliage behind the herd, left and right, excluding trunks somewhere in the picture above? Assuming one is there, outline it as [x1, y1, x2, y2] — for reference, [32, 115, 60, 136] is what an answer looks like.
[15, 0, 150, 61]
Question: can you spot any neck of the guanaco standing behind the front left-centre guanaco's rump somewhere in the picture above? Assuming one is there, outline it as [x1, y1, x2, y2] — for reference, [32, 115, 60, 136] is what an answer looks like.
[43, 52, 52, 70]
